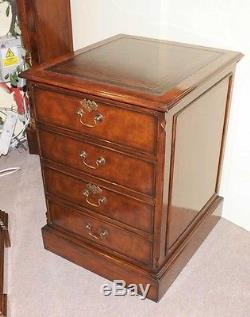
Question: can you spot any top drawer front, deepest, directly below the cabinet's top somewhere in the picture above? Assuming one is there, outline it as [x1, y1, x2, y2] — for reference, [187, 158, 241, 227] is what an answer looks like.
[35, 88, 157, 153]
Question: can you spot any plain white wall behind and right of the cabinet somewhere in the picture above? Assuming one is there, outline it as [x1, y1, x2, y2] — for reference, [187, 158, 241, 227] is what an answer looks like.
[71, 0, 250, 230]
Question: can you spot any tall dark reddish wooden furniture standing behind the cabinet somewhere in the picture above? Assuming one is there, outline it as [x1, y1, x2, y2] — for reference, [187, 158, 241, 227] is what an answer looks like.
[16, 0, 73, 154]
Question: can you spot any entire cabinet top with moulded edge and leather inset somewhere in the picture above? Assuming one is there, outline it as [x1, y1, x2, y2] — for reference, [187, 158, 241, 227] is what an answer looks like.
[23, 34, 243, 112]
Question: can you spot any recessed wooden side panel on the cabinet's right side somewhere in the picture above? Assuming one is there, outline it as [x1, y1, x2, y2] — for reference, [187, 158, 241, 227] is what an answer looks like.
[167, 77, 230, 249]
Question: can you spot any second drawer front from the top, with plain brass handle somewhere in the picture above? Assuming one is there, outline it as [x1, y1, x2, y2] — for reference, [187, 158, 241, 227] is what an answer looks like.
[39, 131, 154, 195]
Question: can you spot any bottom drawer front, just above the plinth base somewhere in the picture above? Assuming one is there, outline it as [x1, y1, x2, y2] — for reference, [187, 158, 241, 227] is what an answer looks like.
[49, 202, 152, 264]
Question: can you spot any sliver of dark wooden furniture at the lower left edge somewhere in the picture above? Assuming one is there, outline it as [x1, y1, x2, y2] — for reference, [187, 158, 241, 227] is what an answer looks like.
[0, 210, 10, 317]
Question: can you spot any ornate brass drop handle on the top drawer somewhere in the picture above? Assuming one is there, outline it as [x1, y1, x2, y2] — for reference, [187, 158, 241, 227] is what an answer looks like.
[76, 99, 104, 128]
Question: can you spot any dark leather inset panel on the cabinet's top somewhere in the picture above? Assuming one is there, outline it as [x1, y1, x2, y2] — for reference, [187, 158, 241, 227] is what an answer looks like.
[48, 37, 223, 94]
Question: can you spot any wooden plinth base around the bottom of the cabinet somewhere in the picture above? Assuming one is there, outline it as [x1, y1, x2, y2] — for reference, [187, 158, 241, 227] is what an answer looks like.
[42, 196, 223, 302]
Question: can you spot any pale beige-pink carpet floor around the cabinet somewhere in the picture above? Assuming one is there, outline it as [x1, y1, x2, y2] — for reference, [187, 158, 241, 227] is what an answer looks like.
[0, 151, 250, 317]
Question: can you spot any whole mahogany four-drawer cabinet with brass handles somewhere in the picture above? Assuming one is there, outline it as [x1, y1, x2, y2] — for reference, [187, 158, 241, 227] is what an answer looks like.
[23, 35, 242, 301]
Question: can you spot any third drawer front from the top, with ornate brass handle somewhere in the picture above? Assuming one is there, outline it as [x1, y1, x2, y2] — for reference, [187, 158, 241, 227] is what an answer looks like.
[44, 167, 153, 233]
